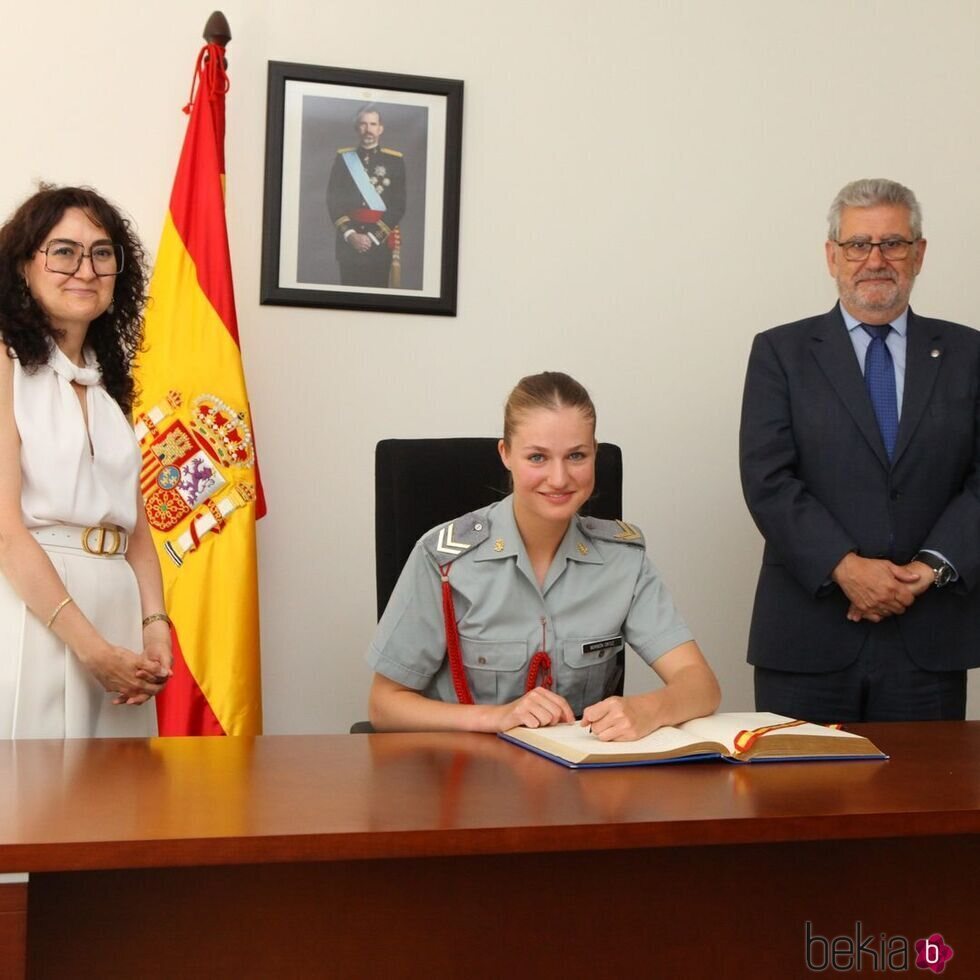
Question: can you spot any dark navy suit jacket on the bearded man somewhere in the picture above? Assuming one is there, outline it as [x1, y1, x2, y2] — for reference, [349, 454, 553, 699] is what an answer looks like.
[739, 306, 980, 673]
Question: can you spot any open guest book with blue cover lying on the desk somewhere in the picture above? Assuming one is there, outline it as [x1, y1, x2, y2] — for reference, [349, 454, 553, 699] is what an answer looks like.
[500, 711, 888, 769]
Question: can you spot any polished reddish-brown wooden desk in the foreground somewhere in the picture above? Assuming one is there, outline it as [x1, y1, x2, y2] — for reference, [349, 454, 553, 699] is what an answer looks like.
[0, 722, 980, 980]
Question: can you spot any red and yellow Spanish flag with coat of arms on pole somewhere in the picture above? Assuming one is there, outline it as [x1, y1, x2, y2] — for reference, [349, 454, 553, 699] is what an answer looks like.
[134, 44, 265, 735]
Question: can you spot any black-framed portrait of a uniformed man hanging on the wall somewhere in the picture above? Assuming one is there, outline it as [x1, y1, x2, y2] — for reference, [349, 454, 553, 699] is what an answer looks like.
[259, 61, 463, 316]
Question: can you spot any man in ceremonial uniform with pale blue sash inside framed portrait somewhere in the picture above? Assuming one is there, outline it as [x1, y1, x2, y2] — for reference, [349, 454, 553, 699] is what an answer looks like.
[327, 105, 405, 287]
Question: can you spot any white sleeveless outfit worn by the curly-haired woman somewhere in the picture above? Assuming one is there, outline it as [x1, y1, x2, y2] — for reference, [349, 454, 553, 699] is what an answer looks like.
[0, 347, 156, 739]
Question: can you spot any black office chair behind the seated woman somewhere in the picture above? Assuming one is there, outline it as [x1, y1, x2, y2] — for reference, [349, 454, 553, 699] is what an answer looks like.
[351, 437, 625, 733]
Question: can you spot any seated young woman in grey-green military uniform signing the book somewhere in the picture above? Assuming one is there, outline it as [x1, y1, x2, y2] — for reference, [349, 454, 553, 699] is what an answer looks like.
[367, 372, 719, 741]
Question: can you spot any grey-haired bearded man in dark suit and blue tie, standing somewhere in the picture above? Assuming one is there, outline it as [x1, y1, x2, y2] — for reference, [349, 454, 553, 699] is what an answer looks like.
[740, 180, 980, 722]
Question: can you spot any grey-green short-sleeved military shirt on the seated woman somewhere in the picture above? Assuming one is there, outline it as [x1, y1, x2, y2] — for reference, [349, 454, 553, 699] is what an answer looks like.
[367, 497, 693, 716]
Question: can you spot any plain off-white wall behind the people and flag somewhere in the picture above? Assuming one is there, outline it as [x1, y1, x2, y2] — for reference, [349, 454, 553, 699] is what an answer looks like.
[0, 0, 980, 733]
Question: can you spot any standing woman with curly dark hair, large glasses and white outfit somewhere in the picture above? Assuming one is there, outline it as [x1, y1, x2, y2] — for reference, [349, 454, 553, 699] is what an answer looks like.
[0, 186, 172, 738]
